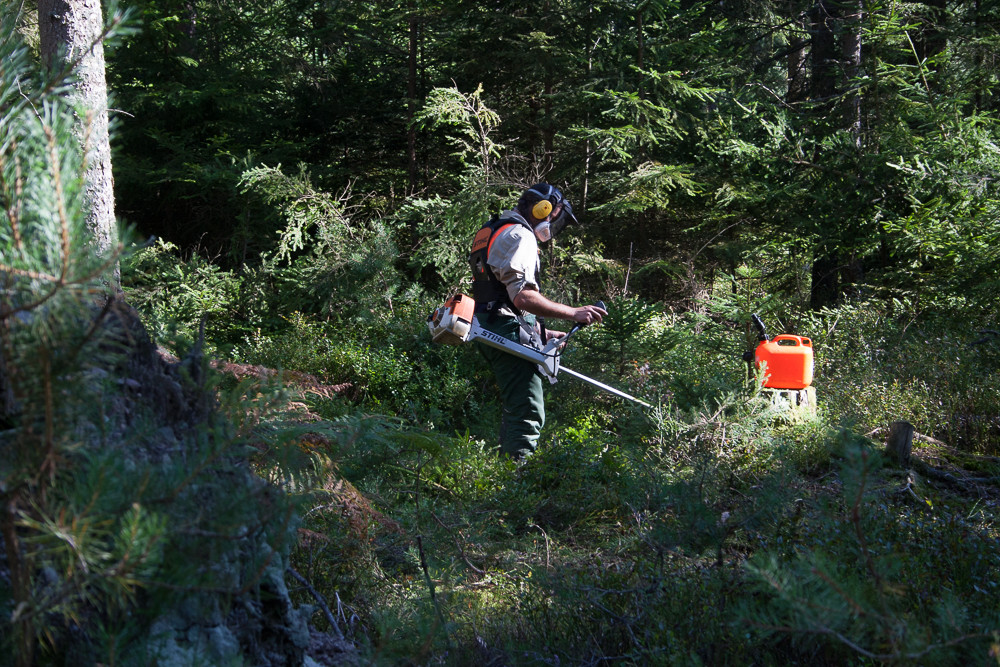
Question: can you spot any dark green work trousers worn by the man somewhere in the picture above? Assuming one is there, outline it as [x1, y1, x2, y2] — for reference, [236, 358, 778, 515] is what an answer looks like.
[478, 315, 545, 459]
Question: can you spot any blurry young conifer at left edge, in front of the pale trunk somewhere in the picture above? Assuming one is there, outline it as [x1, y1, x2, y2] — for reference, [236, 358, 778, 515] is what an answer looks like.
[0, 7, 131, 665]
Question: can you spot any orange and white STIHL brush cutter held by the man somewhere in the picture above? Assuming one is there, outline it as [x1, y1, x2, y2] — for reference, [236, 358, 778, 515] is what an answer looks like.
[427, 294, 653, 408]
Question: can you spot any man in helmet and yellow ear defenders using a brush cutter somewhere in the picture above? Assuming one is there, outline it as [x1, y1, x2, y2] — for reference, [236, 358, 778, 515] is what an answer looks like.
[469, 183, 607, 460]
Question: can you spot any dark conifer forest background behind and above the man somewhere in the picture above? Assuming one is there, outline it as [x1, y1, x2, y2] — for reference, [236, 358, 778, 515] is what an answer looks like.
[110, 1, 997, 310]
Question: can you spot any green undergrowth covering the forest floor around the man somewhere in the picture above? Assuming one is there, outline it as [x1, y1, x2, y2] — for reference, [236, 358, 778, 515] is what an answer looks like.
[123, 244, 1000, 665]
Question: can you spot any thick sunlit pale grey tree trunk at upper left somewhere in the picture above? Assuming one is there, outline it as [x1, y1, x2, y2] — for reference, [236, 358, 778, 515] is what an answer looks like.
[38, 0, 119, 291]
